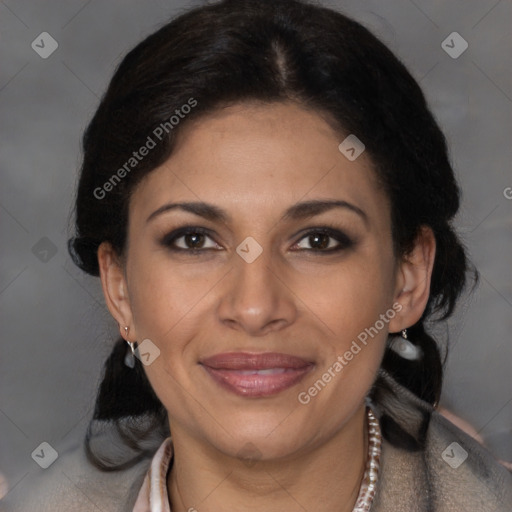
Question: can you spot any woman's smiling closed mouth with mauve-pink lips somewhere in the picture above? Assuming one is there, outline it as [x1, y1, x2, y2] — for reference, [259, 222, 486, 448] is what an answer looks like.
[200, 352, 315, 397]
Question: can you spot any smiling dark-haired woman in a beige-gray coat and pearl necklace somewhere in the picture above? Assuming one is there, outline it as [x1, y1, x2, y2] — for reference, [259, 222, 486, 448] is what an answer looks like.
[8, 0, 512, 512]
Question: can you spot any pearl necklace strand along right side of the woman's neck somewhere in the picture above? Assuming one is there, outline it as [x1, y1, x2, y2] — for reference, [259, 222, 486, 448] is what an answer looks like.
[352, 408, 382, 512]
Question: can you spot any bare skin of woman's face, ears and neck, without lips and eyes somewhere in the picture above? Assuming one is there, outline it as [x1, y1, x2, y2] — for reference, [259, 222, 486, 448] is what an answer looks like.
[98, 103, 435, 512]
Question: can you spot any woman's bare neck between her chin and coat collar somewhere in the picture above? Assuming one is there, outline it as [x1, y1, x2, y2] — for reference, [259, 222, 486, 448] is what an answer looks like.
[167, 404, 368, 512]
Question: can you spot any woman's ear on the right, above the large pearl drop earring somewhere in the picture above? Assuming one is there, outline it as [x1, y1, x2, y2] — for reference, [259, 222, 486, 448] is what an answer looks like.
[389, 226, 436, 332]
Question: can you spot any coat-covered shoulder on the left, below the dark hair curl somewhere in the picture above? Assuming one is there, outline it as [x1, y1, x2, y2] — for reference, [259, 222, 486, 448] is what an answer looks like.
[0, 436, 151, 512]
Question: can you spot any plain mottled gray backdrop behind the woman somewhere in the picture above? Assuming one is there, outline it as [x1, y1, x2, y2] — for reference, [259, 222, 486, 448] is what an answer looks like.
[0, 0, 512, 500]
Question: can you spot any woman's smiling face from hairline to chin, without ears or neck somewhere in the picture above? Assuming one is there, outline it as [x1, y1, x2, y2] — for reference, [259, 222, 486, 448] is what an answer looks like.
[100, 103, 424, 458]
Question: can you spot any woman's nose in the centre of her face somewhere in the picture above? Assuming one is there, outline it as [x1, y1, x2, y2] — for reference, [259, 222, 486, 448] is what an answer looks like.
[218, 250, 297, 337]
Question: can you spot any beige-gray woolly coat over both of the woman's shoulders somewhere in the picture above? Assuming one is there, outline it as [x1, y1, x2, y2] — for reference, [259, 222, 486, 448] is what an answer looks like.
[0, 373, 512, 512]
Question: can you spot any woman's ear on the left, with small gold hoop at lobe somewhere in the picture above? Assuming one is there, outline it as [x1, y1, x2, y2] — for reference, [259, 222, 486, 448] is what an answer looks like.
[98, 242, 137, 341]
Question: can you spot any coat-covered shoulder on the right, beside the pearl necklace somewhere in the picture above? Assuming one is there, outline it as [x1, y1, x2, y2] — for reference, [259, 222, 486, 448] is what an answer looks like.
[374, 374, 512, 512]
